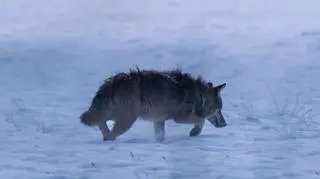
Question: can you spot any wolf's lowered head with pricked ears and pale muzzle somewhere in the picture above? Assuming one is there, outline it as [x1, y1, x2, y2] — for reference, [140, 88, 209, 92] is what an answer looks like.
[195, 83, 227, 128]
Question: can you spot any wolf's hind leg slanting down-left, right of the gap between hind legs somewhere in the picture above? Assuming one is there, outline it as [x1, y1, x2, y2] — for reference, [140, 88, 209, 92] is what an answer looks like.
[107, 117, 137, 140]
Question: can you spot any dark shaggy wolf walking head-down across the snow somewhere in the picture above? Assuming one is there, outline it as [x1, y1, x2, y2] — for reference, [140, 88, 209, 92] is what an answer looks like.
[80, 68, 227, 142]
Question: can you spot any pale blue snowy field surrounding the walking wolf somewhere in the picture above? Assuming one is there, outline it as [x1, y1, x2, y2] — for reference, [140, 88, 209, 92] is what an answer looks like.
[0, 0, 320, 179]
